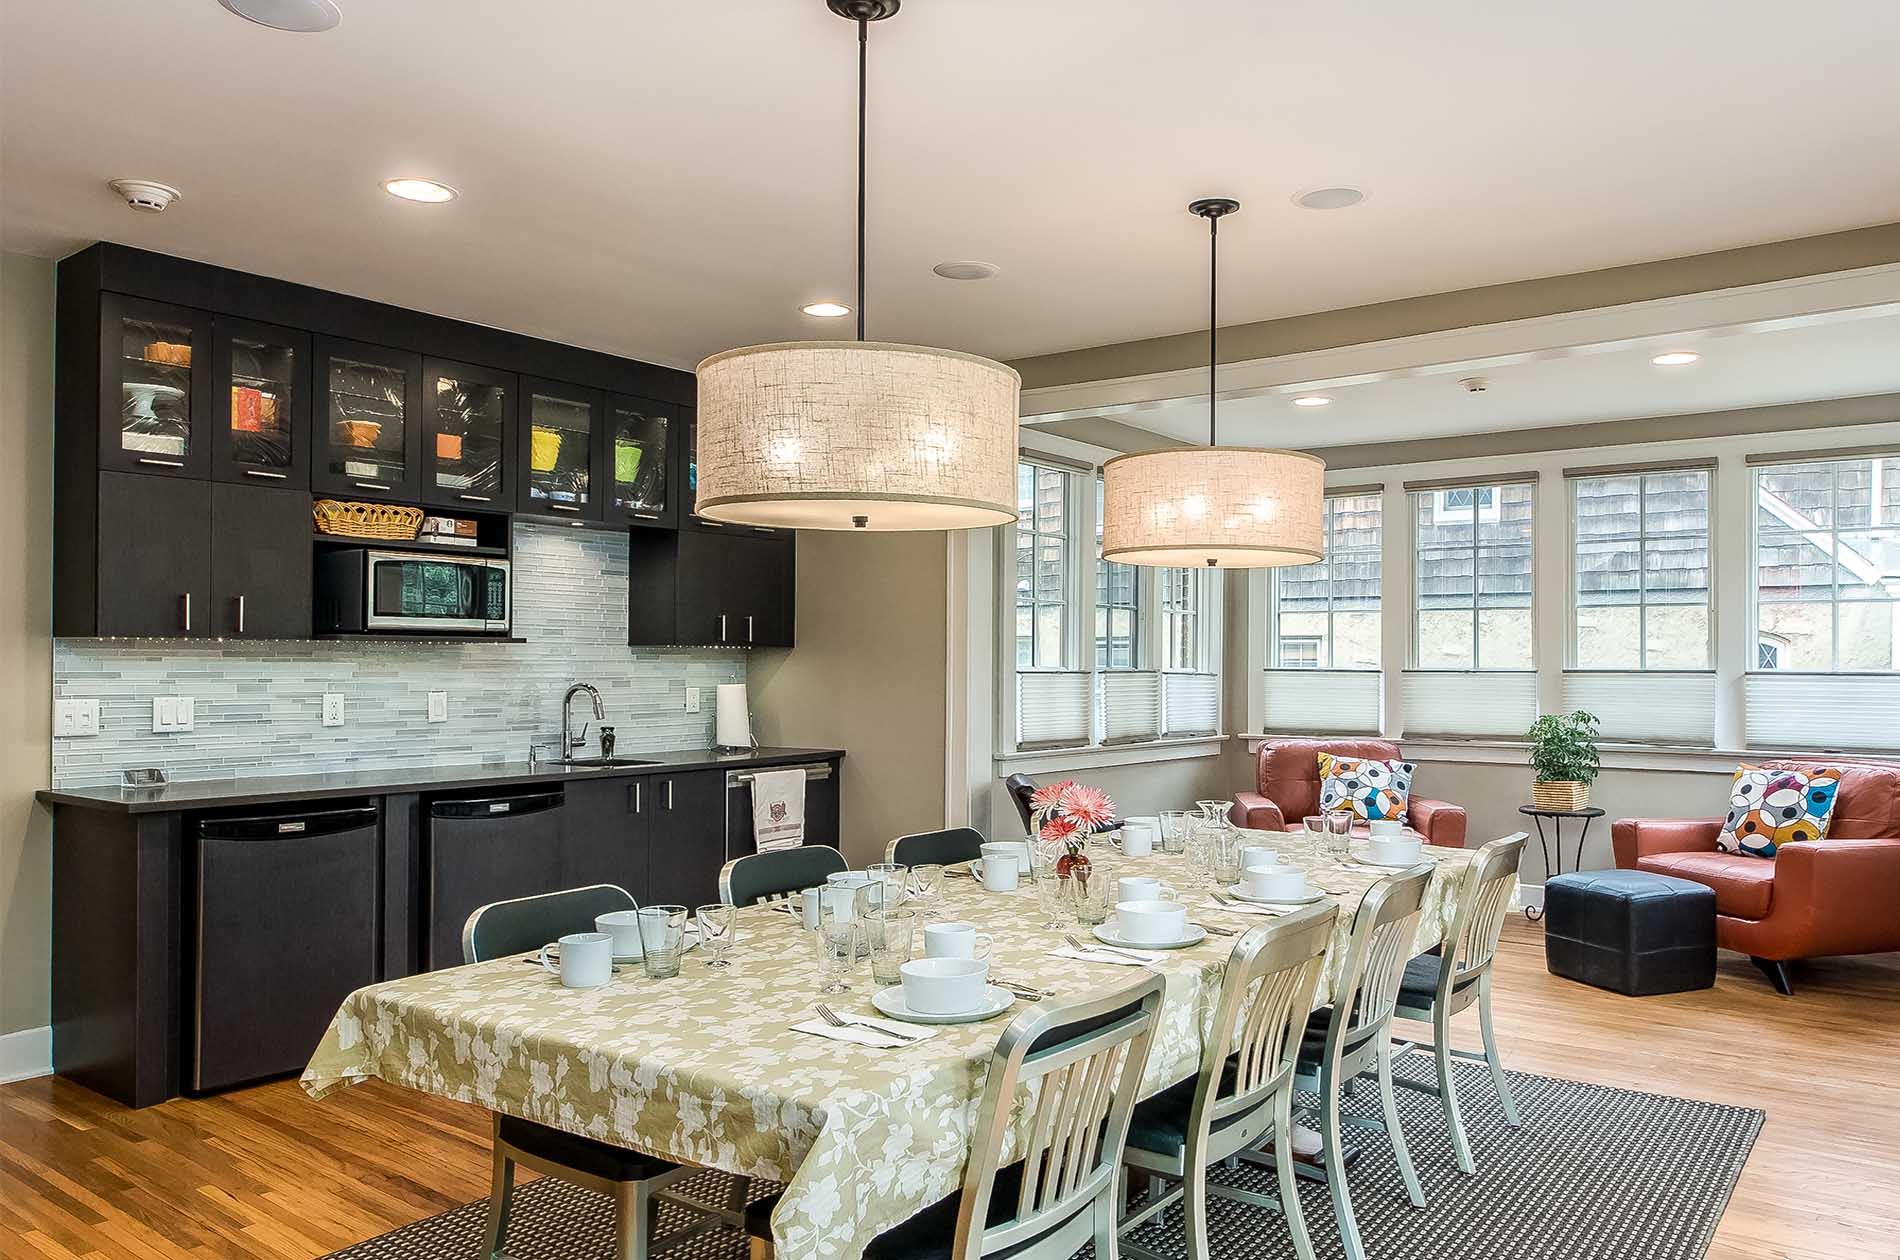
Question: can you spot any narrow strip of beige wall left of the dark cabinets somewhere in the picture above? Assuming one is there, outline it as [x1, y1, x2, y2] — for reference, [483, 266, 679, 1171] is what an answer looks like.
[0, 255, 53, 1034]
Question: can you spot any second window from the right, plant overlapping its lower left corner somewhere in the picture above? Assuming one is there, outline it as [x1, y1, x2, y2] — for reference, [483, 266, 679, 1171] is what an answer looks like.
[1564, 466, 1716, 745]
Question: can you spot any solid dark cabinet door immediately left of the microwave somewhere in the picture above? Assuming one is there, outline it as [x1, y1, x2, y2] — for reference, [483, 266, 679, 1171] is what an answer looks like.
[205, 483, 314, 639]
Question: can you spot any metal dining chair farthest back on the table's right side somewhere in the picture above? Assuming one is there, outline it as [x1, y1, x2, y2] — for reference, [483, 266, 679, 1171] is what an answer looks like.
[1395, 830, 1530, 1176]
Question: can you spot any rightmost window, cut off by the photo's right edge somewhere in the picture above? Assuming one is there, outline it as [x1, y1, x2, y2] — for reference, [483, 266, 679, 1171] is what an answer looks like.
[1744, 456, 1900, 749]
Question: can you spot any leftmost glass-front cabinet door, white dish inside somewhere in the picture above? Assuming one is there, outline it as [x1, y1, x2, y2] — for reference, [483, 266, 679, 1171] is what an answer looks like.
[99, 293, 211, 477]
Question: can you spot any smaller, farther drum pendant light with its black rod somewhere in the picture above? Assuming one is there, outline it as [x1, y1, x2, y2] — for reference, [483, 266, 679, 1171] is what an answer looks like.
[1102, 198, 1326, 568]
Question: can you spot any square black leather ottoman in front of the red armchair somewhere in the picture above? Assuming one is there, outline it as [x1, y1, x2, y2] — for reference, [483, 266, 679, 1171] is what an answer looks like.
[1545, 870, 1716, 998]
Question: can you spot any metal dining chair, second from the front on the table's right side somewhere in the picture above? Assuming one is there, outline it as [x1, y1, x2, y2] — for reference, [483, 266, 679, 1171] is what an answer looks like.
[1121, 901, 1340, 1260]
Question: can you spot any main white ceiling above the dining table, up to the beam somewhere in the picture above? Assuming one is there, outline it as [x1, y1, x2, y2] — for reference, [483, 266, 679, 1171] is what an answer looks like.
[0, 0, 1900, 374]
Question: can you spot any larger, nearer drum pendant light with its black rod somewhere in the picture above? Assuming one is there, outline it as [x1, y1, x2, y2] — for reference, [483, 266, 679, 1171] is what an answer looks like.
[695, 0, 1022, 530]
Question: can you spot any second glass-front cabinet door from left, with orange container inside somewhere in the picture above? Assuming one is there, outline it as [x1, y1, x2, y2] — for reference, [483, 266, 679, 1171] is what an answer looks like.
[211, 315, 310, 490]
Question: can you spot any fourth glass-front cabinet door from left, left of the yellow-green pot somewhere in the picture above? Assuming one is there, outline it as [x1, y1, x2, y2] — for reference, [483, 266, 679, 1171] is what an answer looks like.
[422, 359, 521, 509]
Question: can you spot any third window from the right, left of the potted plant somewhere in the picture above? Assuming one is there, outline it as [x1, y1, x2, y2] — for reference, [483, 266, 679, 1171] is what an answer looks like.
[1402, 475, 1537, 737]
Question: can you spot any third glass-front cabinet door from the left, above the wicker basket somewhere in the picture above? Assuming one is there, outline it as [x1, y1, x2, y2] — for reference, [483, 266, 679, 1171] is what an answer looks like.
[310, 345, 422, 502]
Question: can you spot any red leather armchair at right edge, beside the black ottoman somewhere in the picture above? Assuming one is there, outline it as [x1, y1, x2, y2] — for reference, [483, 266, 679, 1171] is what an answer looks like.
[1609, 760, 1900, 994]
